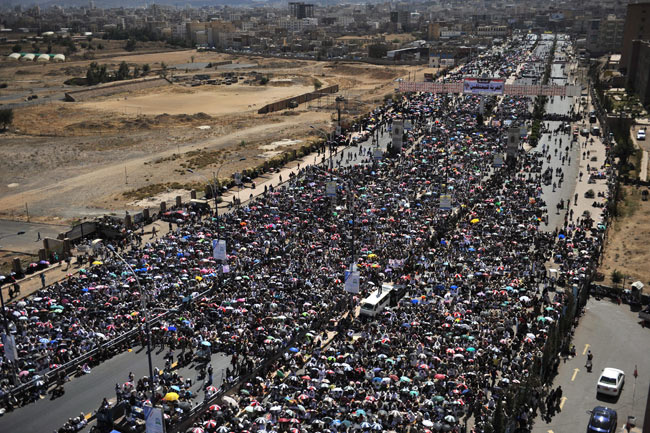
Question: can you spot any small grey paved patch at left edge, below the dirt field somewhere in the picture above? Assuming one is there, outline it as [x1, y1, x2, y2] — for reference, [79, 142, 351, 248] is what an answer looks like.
[0, 220, 69, 253]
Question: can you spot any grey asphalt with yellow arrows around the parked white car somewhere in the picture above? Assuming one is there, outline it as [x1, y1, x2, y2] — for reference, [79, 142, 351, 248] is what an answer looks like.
[533, 298, 650, 433]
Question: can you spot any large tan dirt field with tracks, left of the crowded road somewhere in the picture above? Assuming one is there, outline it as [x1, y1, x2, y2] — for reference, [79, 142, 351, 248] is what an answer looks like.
[0, 47, 424, 221]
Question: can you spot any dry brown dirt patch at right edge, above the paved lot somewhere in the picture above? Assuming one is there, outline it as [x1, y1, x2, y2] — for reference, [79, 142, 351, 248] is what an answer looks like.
[599, 186, 650, 293]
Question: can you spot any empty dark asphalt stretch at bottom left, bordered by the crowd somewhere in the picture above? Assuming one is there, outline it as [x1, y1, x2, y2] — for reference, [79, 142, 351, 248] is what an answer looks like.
[0, 347, 230, 433]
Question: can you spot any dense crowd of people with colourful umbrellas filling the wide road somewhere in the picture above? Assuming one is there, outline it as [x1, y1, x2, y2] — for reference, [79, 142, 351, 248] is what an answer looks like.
[0, 33, 598, 432]
